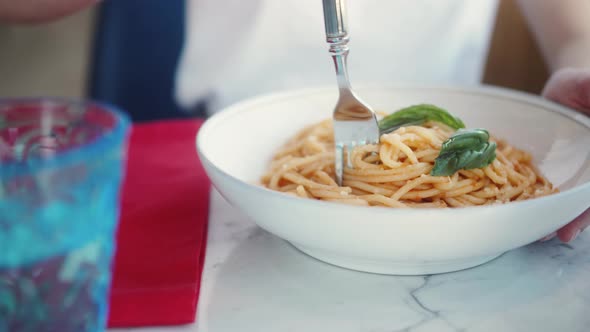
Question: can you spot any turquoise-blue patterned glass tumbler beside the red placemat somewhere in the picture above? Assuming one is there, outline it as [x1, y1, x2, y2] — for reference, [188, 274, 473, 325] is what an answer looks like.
[0, 99, 129, 332]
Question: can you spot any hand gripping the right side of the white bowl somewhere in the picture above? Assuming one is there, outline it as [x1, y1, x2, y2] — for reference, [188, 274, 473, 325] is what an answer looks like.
[543, 68, 590, 242]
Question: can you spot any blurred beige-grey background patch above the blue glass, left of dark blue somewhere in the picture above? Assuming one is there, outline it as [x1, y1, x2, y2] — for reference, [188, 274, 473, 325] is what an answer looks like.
[0, 6, 97, 97]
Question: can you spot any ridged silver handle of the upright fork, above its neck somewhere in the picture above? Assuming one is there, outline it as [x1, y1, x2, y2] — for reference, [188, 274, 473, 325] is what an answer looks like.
[322, 0, 350, 92]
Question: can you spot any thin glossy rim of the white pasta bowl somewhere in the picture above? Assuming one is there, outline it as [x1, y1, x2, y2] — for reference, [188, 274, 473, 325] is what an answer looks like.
[195, 84, 590, 214]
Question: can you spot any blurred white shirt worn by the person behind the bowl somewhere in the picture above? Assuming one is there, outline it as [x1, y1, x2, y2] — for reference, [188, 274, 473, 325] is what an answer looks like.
[176, 0, 497, 110]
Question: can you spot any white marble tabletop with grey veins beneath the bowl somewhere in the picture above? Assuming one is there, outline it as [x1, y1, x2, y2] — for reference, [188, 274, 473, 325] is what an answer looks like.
[109, 192, 590, 332]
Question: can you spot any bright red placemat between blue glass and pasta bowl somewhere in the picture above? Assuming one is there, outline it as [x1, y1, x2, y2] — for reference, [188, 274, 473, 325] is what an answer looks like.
[108, 120, 209, 327]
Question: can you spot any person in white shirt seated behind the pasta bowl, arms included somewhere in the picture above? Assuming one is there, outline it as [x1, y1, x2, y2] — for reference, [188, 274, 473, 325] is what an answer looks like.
[0, 0, 590, 242]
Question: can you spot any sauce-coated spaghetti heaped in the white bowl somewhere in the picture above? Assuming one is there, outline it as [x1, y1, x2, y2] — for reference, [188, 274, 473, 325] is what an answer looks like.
[262, 120, 556, 208]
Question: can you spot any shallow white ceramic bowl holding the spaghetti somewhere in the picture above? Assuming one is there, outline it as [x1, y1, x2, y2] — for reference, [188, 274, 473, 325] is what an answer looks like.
[197, 87, 590, 275]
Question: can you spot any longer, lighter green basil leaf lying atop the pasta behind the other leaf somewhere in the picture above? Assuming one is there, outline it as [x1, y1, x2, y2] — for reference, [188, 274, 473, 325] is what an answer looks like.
[379, 104, 465, 134]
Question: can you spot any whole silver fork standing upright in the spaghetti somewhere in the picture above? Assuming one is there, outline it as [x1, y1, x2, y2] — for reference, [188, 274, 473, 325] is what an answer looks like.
[322, 0, 379, 185]
